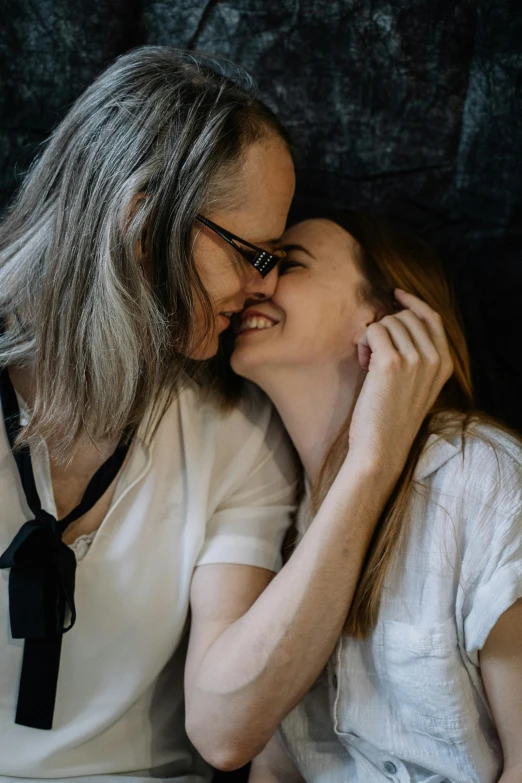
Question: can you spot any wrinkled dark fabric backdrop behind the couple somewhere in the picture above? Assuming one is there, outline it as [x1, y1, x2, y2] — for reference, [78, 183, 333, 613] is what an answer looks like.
[0, 0, 522, 430]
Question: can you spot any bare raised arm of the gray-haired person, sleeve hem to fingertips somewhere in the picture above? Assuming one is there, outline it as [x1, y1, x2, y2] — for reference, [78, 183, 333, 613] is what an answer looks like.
[185, 290, 451, 769]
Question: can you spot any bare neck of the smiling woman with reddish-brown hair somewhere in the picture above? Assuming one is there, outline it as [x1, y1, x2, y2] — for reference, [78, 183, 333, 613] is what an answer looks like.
[255, 363, 364, 483]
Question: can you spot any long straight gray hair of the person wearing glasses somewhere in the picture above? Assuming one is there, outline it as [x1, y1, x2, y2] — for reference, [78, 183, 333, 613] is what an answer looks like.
[0, 46, 288, 457]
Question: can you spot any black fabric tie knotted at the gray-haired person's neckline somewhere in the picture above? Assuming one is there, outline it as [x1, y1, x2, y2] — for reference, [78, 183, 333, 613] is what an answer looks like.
[0, 367, 129, 729]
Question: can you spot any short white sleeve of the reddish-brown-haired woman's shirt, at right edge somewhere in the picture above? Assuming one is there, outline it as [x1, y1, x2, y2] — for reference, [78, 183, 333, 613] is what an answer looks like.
[459, 432, 522, 662]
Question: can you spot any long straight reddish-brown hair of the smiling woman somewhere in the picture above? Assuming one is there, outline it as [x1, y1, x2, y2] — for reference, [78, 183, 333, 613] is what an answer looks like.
[310, 211, 498, 638]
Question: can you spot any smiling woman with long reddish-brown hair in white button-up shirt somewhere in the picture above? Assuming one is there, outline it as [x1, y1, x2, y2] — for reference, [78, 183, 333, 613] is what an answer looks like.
[238, 211, 522, 783]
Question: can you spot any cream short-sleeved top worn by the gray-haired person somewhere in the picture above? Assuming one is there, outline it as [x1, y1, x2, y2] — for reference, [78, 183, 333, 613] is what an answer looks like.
[0, 382, 295, 783]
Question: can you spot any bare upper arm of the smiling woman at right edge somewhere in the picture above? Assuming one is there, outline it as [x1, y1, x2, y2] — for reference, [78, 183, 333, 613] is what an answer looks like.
[480, 599, 522, 783]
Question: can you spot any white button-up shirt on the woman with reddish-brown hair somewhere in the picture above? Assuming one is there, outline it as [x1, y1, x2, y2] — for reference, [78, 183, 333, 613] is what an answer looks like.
[281, 426, 522, 783]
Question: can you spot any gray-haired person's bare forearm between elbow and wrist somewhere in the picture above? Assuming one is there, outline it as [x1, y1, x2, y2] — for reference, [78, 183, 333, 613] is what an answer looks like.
[187, 466, 397, 766]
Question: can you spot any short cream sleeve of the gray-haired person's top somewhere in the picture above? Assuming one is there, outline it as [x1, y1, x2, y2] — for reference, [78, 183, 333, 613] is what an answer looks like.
[197, 388, 297, 571]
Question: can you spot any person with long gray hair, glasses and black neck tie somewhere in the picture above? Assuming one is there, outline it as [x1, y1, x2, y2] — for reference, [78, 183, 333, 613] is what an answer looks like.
[0, 47, 451, 782]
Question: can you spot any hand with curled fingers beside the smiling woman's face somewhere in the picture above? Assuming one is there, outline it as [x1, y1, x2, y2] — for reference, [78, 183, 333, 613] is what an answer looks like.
[347, 289, 453, 473]
